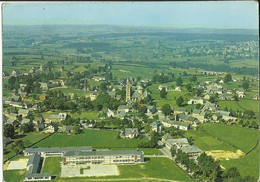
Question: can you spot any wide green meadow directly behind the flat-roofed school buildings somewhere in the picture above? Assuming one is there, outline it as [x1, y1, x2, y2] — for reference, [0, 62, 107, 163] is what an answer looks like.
[34, 130, 146, 149]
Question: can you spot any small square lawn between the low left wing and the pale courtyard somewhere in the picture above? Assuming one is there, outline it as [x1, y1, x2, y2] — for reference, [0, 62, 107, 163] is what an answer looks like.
[42, 157, 62, 176]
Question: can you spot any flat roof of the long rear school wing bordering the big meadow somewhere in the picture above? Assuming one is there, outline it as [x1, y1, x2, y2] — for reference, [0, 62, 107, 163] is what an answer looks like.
[24, 146, 92, 153]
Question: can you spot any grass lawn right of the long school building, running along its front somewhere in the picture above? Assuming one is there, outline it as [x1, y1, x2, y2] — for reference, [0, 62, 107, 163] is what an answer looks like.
[55, 158, 192, 182]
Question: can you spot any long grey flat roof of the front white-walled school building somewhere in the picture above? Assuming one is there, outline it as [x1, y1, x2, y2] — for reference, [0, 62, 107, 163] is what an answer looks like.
[63, 150, 143, 157]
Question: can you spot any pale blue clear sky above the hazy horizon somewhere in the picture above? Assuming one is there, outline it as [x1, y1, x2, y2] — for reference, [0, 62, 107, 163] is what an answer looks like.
[3, 1, 258, 29]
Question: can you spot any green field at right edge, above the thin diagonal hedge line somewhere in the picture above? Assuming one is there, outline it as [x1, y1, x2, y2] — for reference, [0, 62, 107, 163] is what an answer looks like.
[200, 123, 259, 152]
